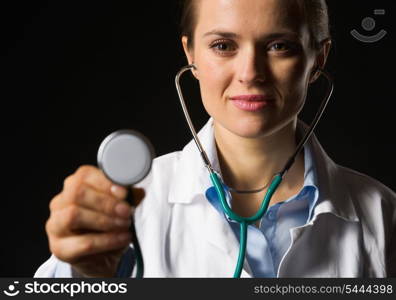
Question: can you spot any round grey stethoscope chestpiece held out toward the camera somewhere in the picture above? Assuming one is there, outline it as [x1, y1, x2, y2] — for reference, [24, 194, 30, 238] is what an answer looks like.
[97, 129, 155, 186]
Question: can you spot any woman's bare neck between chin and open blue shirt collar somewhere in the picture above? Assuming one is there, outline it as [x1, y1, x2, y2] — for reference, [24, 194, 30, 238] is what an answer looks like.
[214, 121, 304, 190]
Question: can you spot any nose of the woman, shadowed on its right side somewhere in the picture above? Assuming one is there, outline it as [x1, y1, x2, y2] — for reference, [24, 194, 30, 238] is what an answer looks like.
[237, 48, 267, 85]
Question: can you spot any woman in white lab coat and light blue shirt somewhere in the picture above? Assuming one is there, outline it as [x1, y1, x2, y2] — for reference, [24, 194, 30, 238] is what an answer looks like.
[35, 0, 396, 277]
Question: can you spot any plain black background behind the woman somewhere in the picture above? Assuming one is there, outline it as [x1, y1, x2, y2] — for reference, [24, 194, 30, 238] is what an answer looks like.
[0, 0, 396, 277]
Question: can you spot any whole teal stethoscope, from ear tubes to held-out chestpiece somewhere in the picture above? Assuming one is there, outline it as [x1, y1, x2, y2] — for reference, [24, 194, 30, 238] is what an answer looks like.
[97, 64, 334, 278]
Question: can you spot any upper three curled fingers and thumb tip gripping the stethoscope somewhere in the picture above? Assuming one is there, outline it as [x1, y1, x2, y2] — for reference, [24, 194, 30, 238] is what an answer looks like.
[46, 166, 145, 238]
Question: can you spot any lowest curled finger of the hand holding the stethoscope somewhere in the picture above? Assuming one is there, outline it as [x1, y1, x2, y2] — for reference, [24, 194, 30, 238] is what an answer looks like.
[50, 231, 131, 263]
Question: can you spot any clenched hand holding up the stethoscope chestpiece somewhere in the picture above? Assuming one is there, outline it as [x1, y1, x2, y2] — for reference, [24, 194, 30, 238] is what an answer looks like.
[46, 166, 145, 274]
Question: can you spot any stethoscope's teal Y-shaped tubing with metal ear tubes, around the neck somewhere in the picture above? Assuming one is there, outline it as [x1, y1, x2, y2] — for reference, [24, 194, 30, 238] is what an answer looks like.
[175, 64, 334, 278]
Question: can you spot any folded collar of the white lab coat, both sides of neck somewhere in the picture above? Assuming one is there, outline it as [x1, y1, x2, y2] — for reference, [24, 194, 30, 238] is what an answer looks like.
[168, 118, 359, 222]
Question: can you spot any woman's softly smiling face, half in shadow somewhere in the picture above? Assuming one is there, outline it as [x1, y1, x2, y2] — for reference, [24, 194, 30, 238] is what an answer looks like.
[182, 0, 328, 138]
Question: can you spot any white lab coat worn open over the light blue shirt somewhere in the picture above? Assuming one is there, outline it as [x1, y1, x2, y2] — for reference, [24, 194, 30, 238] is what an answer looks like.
[35, 119, 396, 277]
